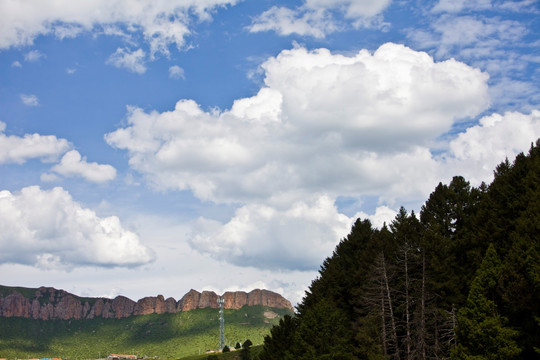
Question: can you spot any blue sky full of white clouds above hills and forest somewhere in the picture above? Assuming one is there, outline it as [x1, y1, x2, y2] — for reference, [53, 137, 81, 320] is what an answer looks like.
[0, 0, 540, 304]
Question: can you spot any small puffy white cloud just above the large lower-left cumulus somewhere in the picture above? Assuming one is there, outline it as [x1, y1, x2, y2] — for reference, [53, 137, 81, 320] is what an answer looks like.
[47, 150, 116, 183]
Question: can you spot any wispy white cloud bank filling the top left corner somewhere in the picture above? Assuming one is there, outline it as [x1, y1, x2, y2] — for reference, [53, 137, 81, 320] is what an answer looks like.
[0, 0, 237, 53]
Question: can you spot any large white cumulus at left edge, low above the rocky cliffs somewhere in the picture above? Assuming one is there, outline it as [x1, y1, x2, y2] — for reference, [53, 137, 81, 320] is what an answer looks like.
[0, 186, 154, 269]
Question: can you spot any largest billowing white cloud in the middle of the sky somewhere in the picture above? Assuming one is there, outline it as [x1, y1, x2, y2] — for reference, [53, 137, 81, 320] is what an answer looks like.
[106, 44, 488, 202]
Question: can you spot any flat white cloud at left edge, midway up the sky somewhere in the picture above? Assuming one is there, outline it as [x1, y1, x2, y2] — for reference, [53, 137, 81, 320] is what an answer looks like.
[0, 122, 71, 164]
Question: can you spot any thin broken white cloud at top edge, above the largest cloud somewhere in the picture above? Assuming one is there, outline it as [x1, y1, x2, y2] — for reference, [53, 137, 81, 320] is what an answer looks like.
[248, 0, 391, 38]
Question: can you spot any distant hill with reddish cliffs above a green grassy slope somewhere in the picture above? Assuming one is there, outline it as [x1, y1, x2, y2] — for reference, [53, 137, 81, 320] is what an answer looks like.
[0, 286, 293, 359]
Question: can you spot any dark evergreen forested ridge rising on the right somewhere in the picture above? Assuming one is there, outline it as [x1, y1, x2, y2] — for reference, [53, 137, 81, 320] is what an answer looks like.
[260, 140, 540, 360]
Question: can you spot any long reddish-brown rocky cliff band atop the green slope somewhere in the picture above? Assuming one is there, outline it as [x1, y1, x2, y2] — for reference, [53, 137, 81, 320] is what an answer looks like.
[0, 286, 293, 320]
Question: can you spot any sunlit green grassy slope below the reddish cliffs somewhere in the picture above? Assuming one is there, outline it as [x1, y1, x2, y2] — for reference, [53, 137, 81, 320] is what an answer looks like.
[0, 306, 290, 359]
